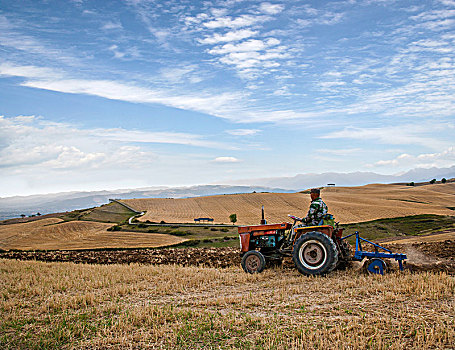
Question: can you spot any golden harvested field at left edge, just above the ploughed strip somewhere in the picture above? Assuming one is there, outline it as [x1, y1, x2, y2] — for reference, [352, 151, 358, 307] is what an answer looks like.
[0, 218, 185, 250]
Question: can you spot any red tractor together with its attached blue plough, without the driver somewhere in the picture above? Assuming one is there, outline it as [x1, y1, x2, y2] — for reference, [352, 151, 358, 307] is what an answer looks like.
[238, 207, 407, 275]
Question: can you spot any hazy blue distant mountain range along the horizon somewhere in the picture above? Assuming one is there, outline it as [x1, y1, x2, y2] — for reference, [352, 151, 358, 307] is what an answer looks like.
[0, 166, 455, 220]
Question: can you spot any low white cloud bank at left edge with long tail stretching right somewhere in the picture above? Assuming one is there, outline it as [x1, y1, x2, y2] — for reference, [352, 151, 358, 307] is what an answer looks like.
[0, 116, 235, 170]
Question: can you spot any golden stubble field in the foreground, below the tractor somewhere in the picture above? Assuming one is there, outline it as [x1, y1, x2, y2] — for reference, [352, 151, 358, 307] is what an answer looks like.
[0, 260, 455, 350]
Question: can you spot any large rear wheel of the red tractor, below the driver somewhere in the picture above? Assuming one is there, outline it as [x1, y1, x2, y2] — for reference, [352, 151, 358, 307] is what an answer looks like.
[292, 231, 338, 275]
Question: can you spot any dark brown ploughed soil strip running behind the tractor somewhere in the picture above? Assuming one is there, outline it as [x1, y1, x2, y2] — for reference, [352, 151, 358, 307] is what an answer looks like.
[0, 240, 455, 274]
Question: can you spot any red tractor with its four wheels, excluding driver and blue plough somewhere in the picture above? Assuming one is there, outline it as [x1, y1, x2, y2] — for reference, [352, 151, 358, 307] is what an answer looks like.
[238, 215, 352, 275]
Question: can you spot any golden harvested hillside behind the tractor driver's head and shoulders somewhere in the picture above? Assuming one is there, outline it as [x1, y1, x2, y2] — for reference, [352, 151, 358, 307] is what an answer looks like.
[124, 183, 455, 225]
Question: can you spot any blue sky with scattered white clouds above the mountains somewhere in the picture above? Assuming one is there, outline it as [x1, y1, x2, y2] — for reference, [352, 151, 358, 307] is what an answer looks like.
[0, 0, 455, 197]
